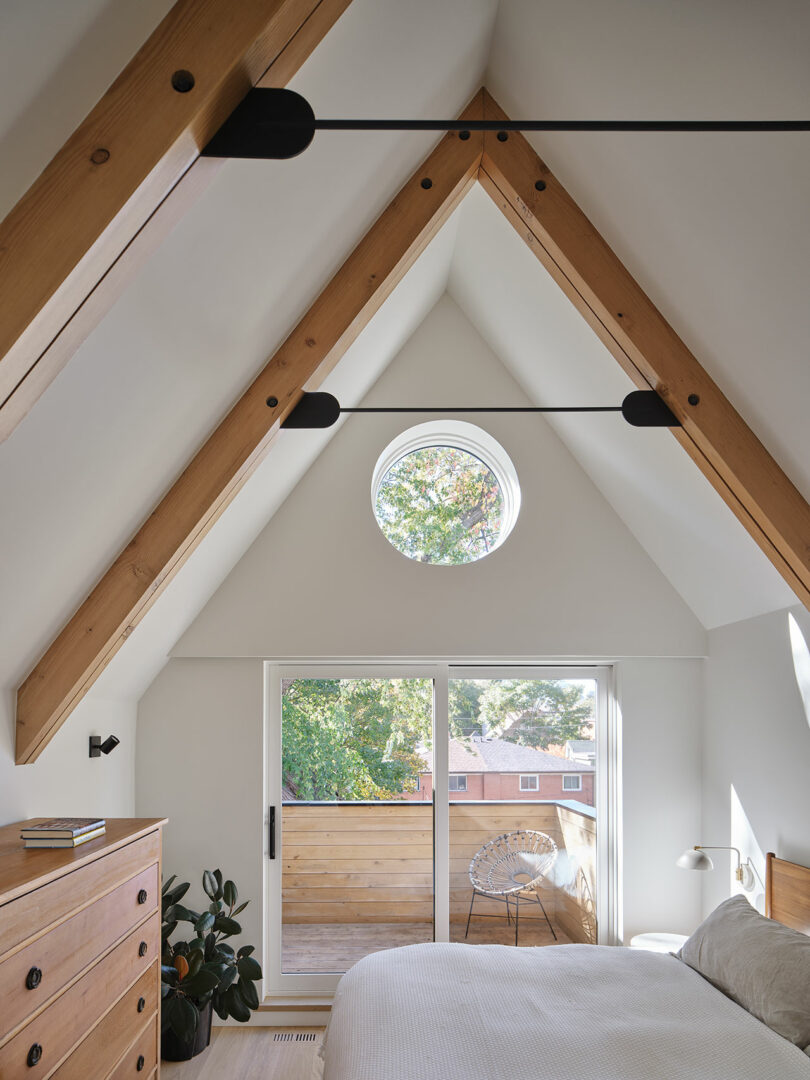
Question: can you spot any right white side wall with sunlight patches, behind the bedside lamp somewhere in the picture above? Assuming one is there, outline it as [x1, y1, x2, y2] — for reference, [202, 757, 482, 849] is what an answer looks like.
[693, 607, 810, 912]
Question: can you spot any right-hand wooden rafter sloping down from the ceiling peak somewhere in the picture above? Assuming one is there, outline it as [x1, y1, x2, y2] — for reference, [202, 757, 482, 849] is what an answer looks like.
[478, 91, 810, 607]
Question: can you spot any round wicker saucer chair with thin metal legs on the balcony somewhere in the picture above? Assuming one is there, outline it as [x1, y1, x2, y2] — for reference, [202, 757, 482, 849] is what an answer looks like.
[464, 829, 557, 945]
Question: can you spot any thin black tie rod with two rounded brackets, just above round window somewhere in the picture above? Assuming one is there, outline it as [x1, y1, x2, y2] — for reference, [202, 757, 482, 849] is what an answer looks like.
[276, 390, 681, 430]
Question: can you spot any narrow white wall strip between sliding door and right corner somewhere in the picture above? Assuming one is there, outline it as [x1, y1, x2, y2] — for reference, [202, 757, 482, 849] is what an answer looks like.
[617, 660, 704, 942]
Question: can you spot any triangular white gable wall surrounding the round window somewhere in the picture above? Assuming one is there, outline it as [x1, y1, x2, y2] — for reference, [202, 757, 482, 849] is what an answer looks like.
[174, 296, 705, 658]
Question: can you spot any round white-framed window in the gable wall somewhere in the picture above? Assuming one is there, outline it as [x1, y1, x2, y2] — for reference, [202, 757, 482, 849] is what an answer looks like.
[372, 420, 521, 566]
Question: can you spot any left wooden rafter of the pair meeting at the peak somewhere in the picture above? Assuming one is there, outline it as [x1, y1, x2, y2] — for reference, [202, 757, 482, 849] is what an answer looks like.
[16, 93, 483, 765]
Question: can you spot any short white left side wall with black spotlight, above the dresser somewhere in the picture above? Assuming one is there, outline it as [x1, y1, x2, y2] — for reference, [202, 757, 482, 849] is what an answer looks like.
[0, 689, 136, 825]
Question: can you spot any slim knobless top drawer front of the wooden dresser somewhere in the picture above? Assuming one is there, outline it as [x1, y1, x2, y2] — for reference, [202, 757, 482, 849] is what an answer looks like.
[0, 831, 160, 957]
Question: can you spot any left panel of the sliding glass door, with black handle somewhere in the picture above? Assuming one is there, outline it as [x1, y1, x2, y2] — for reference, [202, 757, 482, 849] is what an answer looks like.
[266, 667, 434, 990]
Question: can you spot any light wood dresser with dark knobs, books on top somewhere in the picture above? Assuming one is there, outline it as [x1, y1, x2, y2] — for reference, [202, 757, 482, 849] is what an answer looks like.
[0, 818, 165, 1080]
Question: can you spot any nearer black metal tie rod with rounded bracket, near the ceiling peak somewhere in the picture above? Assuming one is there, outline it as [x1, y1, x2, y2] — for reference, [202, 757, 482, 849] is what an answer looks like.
[201, 86, 810, 159]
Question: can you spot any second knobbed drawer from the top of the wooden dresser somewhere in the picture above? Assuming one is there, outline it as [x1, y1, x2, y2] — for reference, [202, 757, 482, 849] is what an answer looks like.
[0, 912, 160, 1080]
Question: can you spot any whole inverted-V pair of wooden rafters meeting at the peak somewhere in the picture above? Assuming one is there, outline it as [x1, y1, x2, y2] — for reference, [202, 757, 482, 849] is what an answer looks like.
[16, 82, 810, 764]
